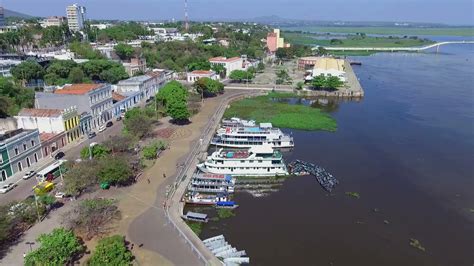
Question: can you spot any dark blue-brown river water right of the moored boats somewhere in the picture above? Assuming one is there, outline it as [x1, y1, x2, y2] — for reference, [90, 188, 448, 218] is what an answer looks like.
[201, 38, 474, 265]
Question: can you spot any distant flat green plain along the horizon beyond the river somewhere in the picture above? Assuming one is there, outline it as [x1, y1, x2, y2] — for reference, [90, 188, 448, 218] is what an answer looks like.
[282, 26, 474, 36]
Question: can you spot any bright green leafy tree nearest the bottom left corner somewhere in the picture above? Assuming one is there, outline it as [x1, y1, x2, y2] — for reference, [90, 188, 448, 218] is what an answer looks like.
[25, 228, 84, 265]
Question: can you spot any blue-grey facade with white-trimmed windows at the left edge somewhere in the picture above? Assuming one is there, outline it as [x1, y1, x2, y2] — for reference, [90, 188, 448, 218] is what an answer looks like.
[0, 129, 43, 182]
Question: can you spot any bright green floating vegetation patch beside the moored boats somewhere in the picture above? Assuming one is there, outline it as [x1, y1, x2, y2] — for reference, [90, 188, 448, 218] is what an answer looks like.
[224, 93, 337, 131]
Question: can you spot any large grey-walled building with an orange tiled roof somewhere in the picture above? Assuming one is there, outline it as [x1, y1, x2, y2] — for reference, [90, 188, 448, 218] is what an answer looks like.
[35, 84, 113, 129]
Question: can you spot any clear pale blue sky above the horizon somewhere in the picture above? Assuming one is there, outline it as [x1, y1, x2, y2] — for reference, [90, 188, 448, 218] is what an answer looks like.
[0, 0, 474, 25]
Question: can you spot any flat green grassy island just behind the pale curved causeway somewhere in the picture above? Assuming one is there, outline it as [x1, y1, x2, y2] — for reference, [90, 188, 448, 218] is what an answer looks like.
[283, 32, 434, 47]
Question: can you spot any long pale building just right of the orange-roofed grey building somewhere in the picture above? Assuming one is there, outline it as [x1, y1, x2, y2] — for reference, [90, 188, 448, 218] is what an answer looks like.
[116, 71, 167, 101]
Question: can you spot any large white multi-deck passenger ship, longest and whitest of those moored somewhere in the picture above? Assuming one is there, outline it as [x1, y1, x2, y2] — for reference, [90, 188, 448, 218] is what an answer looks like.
[197, 143, 288, 176]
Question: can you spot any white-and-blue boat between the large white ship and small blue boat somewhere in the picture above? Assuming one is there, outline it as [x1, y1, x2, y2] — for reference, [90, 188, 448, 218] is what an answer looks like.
[188, 173, 235, 193]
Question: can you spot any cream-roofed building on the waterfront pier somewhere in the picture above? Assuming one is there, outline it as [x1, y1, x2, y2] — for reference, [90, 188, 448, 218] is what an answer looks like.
[305, 57, 346, 82]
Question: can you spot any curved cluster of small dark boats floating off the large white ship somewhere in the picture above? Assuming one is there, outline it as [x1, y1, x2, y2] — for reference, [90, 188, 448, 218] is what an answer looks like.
[288, 160, 339, 192]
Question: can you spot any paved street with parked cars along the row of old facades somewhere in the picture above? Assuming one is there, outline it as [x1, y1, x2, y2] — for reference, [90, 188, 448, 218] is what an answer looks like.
[0, 121, 123, 204]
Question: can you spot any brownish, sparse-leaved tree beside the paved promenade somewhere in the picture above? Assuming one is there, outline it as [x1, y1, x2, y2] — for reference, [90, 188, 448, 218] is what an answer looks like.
[63, 198, 120, 239]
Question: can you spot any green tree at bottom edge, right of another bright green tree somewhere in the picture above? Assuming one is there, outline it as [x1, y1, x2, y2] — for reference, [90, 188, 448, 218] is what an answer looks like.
[87, 235, 133, 266]
